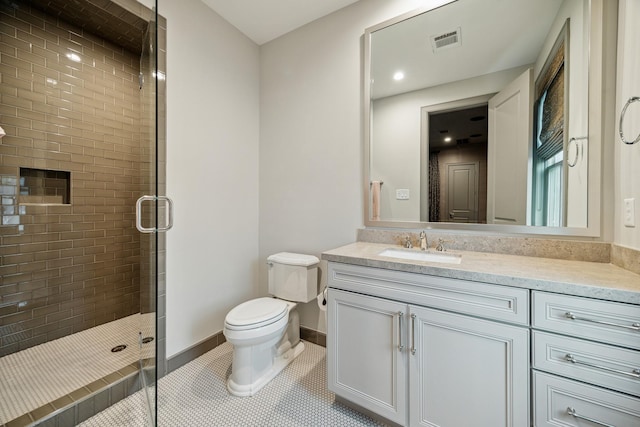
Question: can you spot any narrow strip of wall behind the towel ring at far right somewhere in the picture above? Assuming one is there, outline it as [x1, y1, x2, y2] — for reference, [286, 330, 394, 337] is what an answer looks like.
[612, 0, 640, 250]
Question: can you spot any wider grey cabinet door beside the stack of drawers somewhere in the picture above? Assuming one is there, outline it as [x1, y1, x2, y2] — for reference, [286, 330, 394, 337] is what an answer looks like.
[408, 306, 529, 427]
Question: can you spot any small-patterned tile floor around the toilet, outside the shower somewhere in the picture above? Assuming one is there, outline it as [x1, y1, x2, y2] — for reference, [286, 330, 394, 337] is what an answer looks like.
[81, 342, 384, 427]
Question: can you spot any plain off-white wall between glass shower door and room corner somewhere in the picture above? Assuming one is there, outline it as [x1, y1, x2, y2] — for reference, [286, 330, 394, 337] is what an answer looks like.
[152, 0, 259, 357]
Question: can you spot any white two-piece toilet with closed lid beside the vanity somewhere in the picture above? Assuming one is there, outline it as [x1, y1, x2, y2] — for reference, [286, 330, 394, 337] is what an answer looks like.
[223, 252, 320, 396]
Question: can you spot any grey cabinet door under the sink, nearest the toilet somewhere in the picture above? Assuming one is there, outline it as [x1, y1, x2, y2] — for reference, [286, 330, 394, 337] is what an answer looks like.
[327, 289, 407, 425]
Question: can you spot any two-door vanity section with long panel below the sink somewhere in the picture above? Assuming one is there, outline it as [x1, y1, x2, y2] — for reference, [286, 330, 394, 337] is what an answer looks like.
[327, 262, 530, 427]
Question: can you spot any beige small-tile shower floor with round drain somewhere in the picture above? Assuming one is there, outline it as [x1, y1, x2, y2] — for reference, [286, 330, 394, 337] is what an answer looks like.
[0, 314, 154, 425]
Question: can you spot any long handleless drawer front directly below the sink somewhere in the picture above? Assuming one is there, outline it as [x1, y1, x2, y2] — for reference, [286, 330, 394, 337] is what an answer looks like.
[328, 262, 529, 325]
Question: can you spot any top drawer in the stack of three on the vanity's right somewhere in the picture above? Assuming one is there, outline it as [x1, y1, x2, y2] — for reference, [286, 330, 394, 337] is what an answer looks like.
[531, 291, 640, 349]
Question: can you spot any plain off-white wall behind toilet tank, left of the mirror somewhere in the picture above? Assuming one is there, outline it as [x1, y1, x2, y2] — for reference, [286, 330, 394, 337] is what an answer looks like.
[260, 0, 432, 331]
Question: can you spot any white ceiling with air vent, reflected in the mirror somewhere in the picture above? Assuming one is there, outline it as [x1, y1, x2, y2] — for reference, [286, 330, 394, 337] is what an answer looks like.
[371, 0, 564, 99]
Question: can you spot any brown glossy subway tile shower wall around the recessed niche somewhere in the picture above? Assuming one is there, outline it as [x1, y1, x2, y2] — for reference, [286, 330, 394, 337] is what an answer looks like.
[0, 2, 149, 356]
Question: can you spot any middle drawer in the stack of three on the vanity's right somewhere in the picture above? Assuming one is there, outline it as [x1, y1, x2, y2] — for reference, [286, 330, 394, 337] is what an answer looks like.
[533, 331, 640, 396]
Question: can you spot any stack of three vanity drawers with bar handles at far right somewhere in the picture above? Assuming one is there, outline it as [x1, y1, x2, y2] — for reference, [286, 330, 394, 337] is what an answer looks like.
[532, 291, 640, 427]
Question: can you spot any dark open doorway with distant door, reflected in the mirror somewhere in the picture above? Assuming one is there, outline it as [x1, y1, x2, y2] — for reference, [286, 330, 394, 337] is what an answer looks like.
[427, 102, 488, 223]
